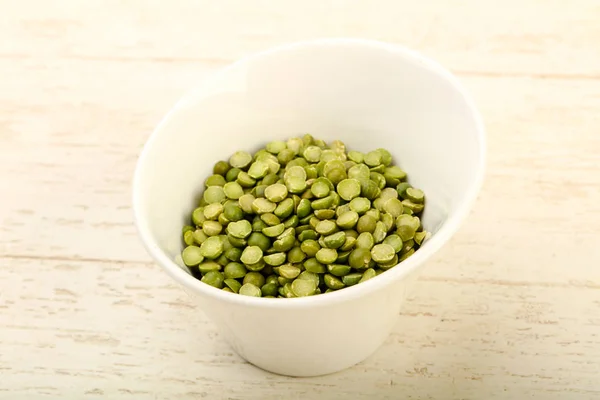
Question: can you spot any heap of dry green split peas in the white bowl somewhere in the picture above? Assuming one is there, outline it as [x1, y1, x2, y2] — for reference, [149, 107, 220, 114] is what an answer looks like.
[181, 134, 429, 298]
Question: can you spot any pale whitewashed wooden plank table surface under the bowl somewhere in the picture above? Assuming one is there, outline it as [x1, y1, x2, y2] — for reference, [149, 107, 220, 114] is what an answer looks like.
[0, 0, 600, 400]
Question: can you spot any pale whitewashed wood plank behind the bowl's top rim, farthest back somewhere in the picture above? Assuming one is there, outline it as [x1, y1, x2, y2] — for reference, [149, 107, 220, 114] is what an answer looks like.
[0, 0, 600, 78]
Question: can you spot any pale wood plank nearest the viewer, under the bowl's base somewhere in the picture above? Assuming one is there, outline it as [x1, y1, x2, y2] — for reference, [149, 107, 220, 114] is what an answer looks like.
[0, 258, 600, 399]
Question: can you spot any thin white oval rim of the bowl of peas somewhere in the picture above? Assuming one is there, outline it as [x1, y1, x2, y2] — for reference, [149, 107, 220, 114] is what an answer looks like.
[132, 38, 486, 309]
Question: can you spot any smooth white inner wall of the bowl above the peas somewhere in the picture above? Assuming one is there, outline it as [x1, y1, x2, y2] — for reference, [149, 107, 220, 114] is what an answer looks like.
[134, 41, 483, 276]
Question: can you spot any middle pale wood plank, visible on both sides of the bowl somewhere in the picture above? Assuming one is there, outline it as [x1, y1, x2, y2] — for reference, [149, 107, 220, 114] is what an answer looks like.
[0, 60, 600, 285]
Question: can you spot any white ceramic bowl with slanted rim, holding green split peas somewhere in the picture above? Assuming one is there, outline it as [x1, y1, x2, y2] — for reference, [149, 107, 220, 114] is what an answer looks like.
[133, 39, 485, 376]
